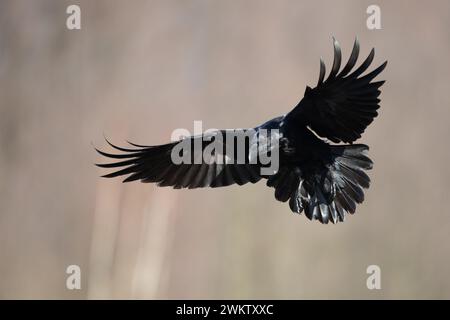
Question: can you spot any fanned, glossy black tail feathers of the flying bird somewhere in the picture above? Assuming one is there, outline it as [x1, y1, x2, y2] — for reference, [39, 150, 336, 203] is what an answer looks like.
[267, 144, 373, 224]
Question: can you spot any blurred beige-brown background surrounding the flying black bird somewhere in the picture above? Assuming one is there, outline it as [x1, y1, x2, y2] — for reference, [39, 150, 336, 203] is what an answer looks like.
[0, 0, 450, 299]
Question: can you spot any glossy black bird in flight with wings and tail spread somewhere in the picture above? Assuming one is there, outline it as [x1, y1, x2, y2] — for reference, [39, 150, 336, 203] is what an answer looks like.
[97, 38, 387, 223]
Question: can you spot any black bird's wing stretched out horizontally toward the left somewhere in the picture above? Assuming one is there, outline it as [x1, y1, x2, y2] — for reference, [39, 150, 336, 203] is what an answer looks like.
[96, 130, 261, 189]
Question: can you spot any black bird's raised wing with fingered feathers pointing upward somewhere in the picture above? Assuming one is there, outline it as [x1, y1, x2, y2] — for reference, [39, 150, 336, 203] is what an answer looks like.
[287, 38, 387, 143]
